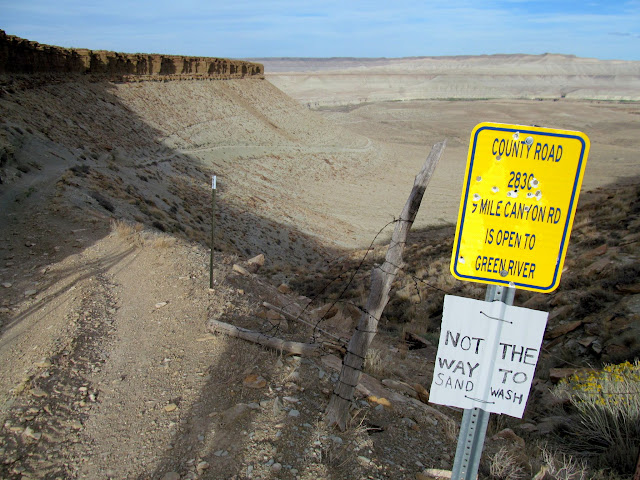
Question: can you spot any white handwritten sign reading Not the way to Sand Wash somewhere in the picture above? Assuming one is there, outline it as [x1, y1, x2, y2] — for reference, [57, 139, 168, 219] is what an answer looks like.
[429, 295, 548, 418]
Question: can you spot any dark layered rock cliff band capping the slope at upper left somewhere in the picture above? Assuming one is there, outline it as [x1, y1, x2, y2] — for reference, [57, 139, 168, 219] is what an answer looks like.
[0, 30, 264, 79]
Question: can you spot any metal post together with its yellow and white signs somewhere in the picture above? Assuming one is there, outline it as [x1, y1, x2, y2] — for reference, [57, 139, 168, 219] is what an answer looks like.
[438, 122, 589, 480]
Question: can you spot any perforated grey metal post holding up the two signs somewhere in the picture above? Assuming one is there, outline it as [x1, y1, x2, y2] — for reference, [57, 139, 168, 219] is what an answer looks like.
[451, 285, 516, 480]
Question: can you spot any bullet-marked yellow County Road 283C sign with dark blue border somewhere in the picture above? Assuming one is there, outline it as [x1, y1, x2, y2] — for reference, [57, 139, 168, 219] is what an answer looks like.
[451, 123, 589, 292]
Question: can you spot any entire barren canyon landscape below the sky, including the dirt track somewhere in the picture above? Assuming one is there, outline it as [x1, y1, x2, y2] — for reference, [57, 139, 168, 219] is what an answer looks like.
[0, 33, 640, 480]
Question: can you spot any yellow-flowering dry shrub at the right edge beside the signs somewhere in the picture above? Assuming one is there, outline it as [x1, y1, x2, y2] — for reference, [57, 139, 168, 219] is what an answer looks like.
[554, 360, 640, 473]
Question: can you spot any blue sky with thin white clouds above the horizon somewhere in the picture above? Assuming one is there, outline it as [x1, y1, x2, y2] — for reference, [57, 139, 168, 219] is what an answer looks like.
[0, 0, 640, 60]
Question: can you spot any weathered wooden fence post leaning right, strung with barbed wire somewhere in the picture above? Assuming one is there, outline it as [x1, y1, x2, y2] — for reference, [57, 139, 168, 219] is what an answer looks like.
[325, 141, 446, 430]
